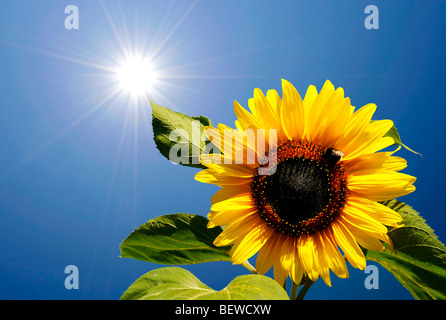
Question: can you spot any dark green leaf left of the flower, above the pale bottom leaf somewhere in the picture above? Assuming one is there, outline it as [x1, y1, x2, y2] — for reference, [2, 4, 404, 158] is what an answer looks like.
[121, 213, 230, 265]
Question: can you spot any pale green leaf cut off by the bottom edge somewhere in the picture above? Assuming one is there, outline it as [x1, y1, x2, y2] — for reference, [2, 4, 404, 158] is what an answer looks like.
[121, 267, 289, 300]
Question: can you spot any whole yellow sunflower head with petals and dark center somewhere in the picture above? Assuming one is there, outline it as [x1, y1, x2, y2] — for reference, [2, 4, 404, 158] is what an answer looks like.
[195, 80, 416, 286]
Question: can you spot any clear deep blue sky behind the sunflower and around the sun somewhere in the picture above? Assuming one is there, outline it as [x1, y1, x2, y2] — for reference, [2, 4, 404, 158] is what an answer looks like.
[0, 0, 446, 299]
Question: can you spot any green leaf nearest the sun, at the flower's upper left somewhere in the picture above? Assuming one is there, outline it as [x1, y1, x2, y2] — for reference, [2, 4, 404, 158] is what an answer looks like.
[150, 101, 212, 169]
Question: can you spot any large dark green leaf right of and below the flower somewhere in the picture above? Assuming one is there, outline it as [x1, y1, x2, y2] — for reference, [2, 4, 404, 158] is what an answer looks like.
[366, 200, 446, 300]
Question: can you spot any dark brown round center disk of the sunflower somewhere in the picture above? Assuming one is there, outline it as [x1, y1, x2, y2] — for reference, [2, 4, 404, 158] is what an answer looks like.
[251, 141, 348, 236]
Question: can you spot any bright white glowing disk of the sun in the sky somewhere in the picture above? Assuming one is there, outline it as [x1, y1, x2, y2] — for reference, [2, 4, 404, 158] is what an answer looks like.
[116, 56, 158, 97]
